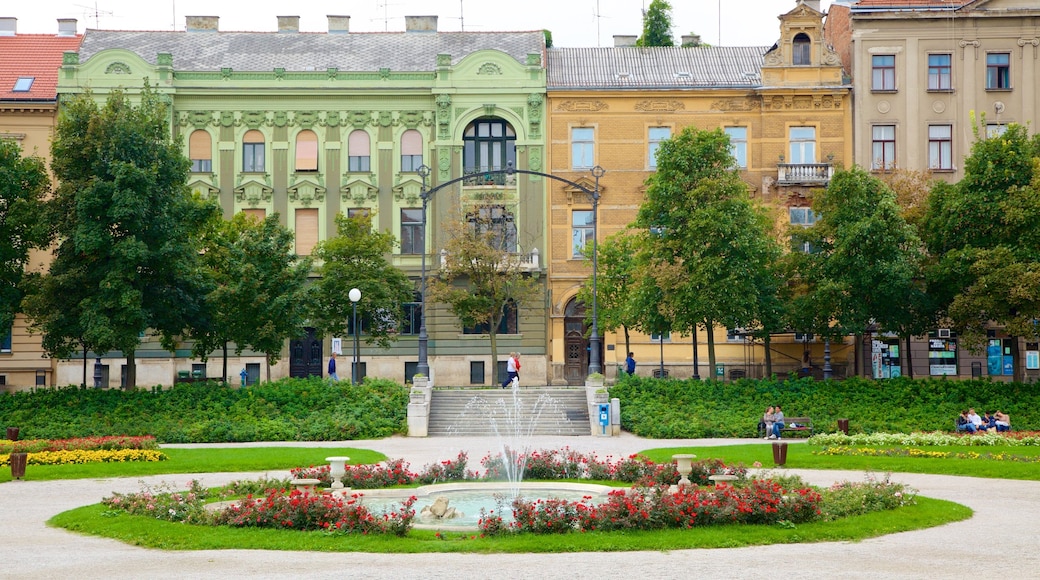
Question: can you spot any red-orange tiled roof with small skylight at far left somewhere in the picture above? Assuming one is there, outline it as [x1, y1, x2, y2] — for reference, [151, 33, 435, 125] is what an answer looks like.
[0, 34, 83, 101]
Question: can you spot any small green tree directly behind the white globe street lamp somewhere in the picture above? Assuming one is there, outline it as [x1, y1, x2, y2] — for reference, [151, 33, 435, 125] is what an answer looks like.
[311, 214, 415, 348]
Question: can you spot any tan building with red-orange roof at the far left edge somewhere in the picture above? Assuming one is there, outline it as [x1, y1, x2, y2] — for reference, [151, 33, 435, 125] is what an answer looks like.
[0, 18, 81, 391]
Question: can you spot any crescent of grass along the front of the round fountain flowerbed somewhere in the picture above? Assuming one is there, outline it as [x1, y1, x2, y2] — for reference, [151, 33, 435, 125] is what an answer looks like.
[48, 497, 971, 554]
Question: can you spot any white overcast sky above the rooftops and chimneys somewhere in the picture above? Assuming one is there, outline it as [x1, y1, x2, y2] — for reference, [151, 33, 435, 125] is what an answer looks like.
[14, 0, 831, 47]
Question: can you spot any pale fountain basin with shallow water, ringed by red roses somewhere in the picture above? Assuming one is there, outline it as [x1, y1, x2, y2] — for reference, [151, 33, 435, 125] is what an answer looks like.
[355, 481, 623, 531]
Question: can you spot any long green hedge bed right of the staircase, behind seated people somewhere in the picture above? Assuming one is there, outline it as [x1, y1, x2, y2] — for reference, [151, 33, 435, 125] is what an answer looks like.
[610, 376, 1040, 439]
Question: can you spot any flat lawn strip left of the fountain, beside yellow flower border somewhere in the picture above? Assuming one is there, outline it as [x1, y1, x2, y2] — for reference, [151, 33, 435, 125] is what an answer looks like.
[0, 447, 387, 482]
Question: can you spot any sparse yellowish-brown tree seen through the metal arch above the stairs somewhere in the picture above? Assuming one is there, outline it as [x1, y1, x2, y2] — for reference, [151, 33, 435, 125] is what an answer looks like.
[428, 200, 541, 372]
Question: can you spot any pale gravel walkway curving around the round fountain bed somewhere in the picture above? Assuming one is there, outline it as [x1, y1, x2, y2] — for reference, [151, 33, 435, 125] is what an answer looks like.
[6, 434, 1040, 580]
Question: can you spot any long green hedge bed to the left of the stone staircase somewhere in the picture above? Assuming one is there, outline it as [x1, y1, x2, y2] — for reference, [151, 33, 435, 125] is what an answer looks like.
[0, 377, 409, 443]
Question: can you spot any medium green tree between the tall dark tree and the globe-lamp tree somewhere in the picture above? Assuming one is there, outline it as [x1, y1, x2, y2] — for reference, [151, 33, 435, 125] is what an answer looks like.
[190, 213, 311, 378]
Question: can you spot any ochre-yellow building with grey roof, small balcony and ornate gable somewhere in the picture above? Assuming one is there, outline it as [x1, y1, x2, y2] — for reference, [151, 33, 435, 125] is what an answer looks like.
[546, 0, 853, 384]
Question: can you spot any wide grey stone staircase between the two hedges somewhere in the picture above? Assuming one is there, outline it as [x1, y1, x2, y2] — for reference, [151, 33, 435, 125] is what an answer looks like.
[428, 387, 591, 437]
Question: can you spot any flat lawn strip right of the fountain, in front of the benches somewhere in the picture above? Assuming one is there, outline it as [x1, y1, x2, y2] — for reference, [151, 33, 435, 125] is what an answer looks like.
[641, 444, 1040, 481]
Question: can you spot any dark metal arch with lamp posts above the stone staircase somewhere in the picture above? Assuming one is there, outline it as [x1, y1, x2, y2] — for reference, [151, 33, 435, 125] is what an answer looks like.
[416, 163, 606, 377]
